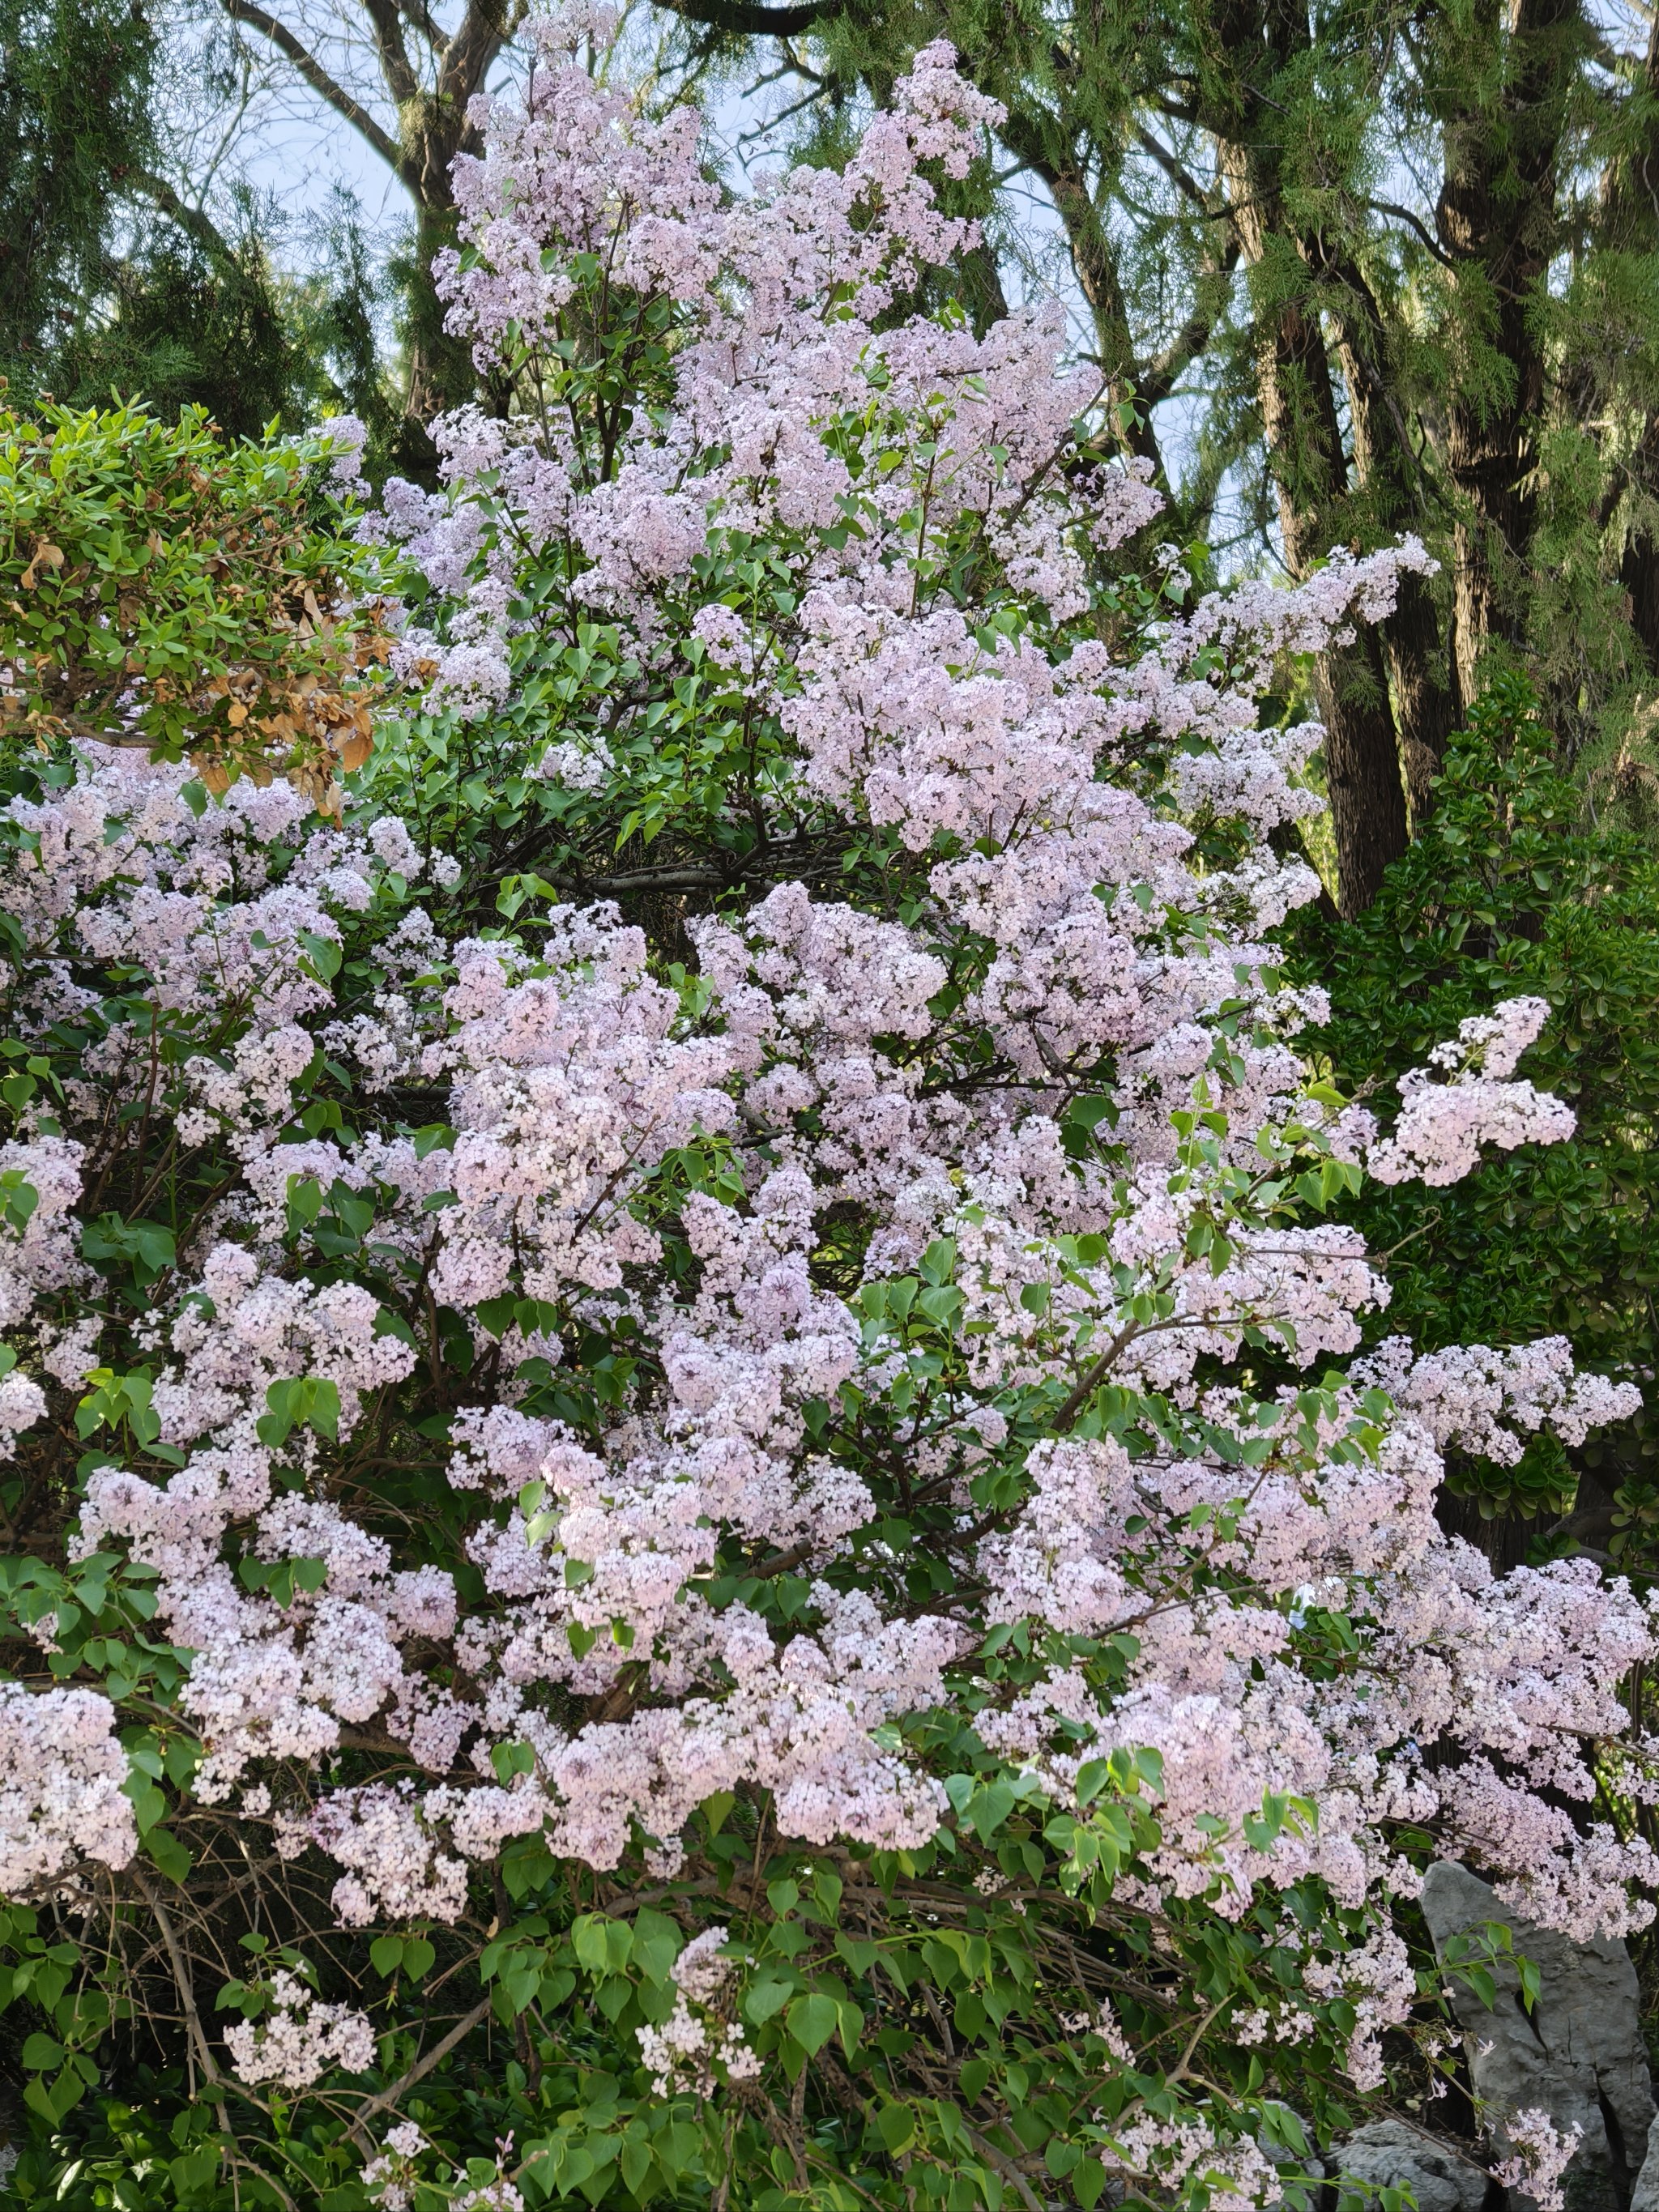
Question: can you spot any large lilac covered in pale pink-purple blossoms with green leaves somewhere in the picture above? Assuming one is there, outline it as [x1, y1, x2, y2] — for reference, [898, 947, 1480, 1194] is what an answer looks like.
[0, 15, 1659, 2212]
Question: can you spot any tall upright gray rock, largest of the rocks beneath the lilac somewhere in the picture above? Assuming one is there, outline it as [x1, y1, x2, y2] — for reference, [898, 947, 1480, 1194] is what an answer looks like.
[1422, 1860, 1659, 2212]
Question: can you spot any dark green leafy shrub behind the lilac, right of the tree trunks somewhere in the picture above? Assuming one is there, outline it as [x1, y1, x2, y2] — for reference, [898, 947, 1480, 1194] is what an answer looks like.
[1290, 679, 1659, 1568]
